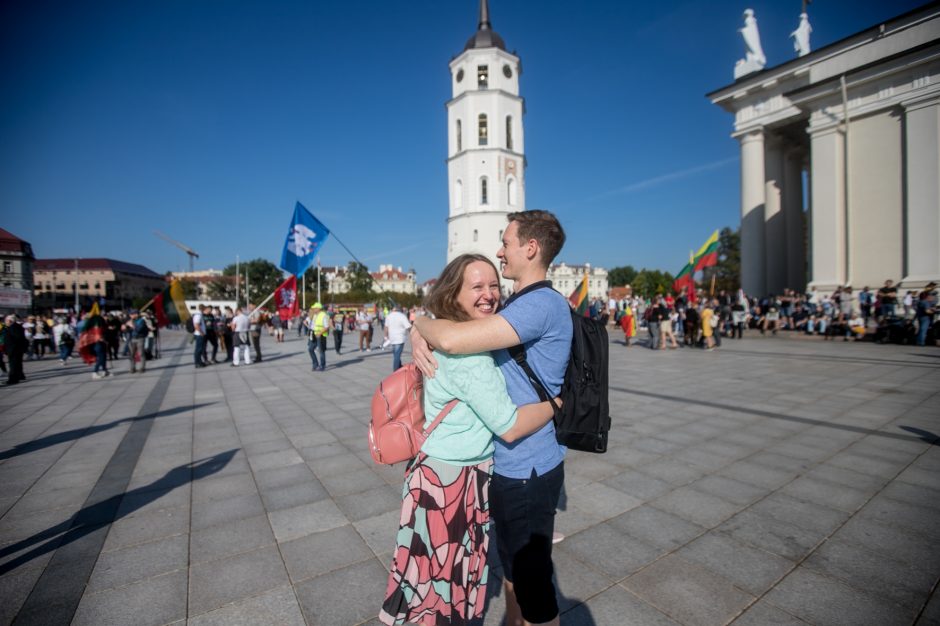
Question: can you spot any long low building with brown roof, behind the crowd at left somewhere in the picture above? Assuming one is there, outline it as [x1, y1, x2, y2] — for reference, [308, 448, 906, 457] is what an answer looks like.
[33, 259, 166, 308]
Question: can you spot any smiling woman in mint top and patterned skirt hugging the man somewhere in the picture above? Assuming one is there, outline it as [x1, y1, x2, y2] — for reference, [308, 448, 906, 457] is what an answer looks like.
[379, 254, 552, 624]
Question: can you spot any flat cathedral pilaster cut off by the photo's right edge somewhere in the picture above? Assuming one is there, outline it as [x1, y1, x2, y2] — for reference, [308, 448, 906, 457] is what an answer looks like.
[903, 96, 940, 284]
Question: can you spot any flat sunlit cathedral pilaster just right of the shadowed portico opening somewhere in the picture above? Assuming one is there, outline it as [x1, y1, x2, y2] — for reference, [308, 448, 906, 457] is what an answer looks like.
[810, 125, 846, 291]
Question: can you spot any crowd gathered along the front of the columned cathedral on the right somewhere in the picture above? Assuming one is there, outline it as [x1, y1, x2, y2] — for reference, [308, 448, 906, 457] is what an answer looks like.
[589, 280, 940, 350]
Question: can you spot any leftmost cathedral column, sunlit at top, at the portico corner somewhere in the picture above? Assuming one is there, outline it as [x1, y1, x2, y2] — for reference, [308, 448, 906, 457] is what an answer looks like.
[738, 130, 766, 297]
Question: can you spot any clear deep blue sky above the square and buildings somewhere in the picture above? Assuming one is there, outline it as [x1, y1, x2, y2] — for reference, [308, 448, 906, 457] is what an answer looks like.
[0, 0, 924, 281]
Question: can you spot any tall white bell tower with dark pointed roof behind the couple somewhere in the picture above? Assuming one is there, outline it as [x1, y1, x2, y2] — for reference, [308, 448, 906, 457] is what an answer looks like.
[447, 0, 526, 268]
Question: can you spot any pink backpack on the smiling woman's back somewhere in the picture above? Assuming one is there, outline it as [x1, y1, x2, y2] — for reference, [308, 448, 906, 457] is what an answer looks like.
[369, 363, 457, 465]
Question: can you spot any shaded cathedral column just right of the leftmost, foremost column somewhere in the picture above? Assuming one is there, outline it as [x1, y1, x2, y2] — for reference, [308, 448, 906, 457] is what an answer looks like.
[764, 135, 787, 294]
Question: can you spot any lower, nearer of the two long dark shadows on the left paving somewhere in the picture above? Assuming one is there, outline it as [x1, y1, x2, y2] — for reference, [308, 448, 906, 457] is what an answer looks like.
[0, 448, 238, 576]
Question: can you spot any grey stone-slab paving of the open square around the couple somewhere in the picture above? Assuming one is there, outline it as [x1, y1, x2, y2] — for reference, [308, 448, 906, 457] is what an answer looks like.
[0, 332, 940, 626]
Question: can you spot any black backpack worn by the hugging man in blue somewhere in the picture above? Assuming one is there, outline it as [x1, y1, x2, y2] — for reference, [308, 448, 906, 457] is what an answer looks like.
[509, 283, 610, 453]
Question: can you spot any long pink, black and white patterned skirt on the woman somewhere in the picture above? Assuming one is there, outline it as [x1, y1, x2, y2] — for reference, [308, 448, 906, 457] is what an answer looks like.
[379, 458, 493, 626]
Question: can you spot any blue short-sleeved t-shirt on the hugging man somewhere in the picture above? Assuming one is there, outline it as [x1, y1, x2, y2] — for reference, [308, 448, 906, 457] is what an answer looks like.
[493, 283, 571, 479]
